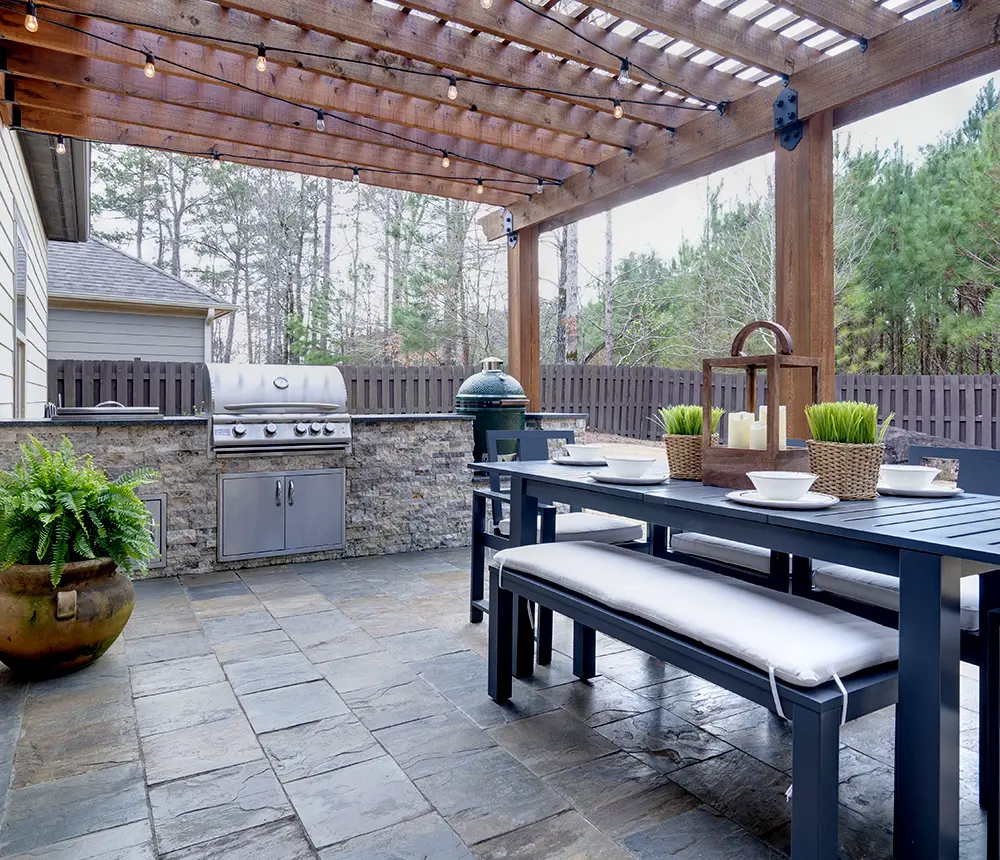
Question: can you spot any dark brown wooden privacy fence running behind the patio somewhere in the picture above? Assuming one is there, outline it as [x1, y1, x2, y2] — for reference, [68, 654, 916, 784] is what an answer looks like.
[49, 360, 1000, 448]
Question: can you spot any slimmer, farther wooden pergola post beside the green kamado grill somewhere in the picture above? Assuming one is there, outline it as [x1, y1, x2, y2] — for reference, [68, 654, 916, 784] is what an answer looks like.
[507, 222, 542, 412]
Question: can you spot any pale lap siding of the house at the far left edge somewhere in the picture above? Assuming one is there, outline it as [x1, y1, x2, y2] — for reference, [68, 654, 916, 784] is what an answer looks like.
[0, 125, 48, 419]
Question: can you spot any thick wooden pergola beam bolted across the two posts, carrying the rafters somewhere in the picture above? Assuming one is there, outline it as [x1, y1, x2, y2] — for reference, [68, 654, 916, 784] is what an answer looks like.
[481, 2, 997, 239]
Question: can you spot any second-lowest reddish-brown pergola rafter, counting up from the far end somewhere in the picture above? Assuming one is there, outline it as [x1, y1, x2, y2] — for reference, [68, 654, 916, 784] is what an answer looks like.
[7, 79, 533, 202]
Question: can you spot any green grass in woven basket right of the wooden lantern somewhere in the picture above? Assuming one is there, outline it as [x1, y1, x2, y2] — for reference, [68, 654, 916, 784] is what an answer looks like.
[806, 401, 893, 499]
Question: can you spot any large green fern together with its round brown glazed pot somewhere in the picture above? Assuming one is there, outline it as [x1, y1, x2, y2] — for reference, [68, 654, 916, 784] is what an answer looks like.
[0, 438, 159, 677]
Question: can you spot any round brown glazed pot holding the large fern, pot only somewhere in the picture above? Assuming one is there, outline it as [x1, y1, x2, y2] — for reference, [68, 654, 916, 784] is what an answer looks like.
[0, 558, 135, 677]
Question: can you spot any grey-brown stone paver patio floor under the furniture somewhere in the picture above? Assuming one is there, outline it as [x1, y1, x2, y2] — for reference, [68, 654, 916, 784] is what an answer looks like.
[0, 550, 985, 860]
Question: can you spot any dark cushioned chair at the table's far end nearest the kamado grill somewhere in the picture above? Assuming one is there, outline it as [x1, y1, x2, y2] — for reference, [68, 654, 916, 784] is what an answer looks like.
[469, 430, 647, 665]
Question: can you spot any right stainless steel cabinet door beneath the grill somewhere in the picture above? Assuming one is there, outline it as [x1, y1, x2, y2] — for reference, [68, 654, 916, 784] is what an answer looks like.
[284, 469, 344, 553]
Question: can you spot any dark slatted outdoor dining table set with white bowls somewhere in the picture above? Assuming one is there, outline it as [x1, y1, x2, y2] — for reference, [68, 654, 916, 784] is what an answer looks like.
[476, 462, 1000, 860]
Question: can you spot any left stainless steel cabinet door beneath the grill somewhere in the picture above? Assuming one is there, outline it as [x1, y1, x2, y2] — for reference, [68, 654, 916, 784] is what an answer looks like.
[219, 474, 287, 559]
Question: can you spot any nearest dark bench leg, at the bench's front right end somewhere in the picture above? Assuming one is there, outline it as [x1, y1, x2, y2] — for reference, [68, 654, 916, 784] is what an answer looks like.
[792, 707, 840, 860]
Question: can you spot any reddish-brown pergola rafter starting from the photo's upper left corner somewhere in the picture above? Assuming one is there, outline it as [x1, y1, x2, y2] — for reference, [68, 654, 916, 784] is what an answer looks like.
[0, 10, 616, 164]
